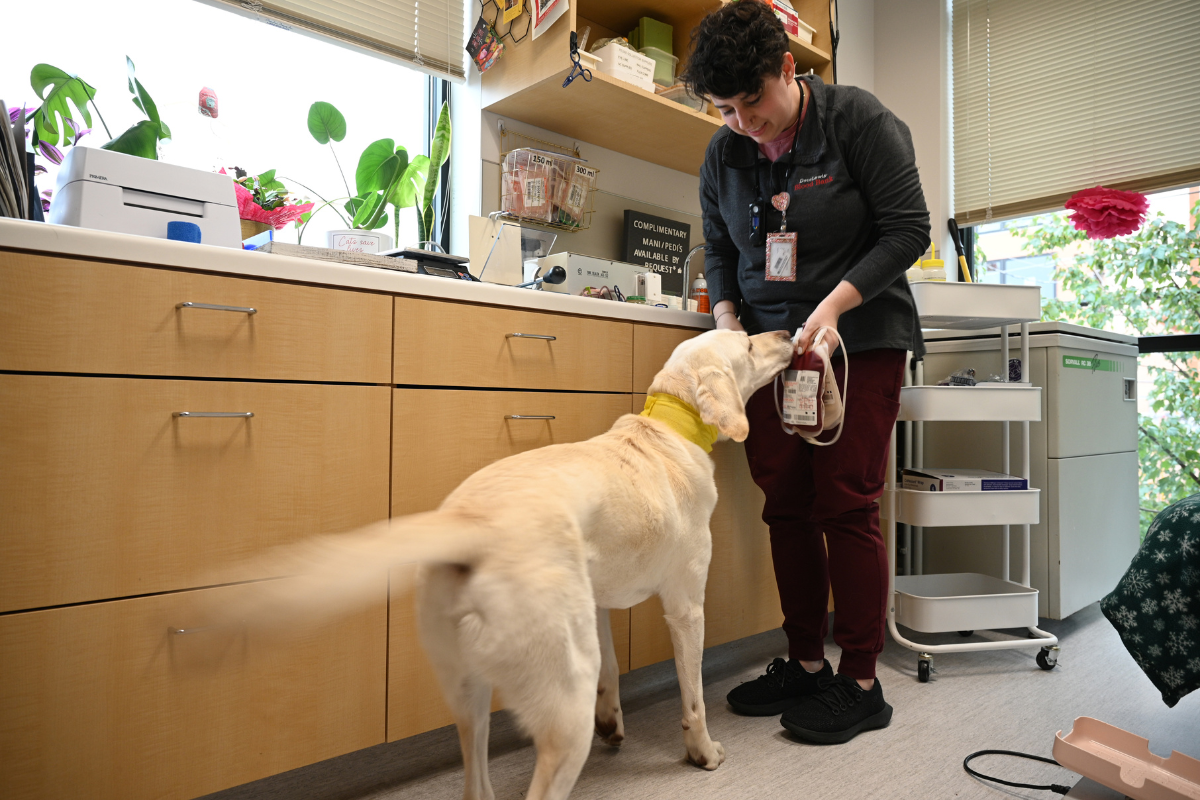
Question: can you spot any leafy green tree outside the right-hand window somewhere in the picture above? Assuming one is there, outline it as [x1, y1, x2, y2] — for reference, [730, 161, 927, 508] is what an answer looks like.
[1022, 204, 1200, 530]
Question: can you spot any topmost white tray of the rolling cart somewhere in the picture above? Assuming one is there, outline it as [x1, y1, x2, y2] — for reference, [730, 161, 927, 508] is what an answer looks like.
[908, 281, 1042, 330]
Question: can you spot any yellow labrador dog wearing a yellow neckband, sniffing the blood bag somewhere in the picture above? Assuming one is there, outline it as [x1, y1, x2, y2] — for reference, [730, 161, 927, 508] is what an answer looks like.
[240, 331, 792, 800]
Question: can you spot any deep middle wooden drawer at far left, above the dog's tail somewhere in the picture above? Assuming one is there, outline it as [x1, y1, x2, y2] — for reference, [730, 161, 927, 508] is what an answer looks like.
[0, 375, 391, 612]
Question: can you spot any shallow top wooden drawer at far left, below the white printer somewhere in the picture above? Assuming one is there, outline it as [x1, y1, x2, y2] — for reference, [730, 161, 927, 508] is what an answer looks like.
[0, 252, 391, 384]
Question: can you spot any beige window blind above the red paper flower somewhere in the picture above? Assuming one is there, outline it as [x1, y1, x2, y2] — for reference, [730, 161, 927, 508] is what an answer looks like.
[953, 0, 1200, 224]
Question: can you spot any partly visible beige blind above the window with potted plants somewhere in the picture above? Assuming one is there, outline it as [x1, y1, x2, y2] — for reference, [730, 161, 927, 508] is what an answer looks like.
[202, 0, 466, 83]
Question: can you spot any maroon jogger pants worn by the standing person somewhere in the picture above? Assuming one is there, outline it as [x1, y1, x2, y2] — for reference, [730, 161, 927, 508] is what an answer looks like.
[745, 349, 906, 680]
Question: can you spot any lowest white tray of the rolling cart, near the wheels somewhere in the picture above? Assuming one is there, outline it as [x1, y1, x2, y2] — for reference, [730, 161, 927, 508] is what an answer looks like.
[895, 572, 1038, 633]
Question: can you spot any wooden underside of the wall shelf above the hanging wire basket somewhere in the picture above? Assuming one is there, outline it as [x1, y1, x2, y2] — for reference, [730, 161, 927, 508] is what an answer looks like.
[485, 70, 721, 175]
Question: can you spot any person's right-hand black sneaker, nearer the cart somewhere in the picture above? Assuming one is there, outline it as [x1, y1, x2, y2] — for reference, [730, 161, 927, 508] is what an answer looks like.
[780, 675, 892, 745]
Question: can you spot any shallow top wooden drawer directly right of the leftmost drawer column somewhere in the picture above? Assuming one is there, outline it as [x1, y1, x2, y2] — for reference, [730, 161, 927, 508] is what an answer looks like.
[394, 297, 634, 392]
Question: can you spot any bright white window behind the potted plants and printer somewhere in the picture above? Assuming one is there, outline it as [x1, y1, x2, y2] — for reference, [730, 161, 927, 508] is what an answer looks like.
[0, 0, 430, 245]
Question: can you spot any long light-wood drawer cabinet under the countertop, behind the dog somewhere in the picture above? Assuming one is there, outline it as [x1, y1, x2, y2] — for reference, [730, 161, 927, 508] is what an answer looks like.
[0, 251, 778, 800]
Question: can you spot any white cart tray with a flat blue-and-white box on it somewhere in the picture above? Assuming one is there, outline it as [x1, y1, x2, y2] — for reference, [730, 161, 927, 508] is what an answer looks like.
[895, 489, 1042, 528]
